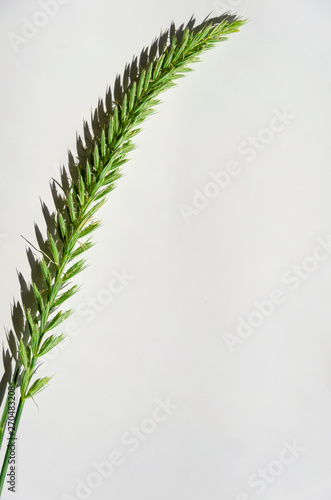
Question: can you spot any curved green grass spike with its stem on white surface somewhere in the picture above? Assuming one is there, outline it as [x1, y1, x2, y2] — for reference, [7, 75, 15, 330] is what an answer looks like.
[0, 14, 246, 493]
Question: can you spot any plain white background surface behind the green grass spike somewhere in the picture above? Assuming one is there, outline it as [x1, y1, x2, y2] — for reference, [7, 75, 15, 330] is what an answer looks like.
[0, 0, 331, 500]
